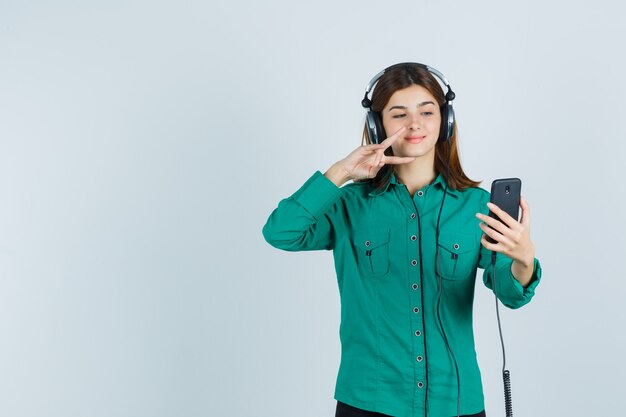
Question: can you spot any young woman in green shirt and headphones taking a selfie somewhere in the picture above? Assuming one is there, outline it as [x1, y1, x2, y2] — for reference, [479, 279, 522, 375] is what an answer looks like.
[263, 63, 541, 417]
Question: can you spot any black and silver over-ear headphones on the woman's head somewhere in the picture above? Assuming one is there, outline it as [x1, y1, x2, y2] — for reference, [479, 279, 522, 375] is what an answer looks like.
[361, 62, 455, 143]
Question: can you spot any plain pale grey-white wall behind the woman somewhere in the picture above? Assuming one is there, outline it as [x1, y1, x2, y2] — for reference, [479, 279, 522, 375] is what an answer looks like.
[0, 0, 626, 417]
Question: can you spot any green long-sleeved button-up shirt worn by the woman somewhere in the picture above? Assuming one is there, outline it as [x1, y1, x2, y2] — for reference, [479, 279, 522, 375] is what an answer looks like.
[263, 171, 541, 417]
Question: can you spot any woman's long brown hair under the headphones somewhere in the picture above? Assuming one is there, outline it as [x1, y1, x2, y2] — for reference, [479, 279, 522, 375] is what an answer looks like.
[362, 64, 480, 191]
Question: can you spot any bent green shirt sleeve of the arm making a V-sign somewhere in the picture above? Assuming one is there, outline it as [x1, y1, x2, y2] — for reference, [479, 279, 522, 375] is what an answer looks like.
[263, 171, 341, 251]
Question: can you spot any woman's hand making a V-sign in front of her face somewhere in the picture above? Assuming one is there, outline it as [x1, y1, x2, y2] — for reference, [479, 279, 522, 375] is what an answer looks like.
[325, 127, 415, 185]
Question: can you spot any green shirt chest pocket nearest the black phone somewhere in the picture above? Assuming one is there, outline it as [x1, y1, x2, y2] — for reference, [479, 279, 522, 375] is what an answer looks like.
[435, 231, 480, 280]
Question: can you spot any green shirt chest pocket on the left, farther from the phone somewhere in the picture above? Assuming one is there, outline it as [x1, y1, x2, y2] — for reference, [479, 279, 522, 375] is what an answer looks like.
[353, 227, 390, 277]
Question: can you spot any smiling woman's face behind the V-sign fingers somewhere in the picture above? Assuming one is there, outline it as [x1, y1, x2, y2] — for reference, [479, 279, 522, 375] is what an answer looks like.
[382, 84, 441, 159]
